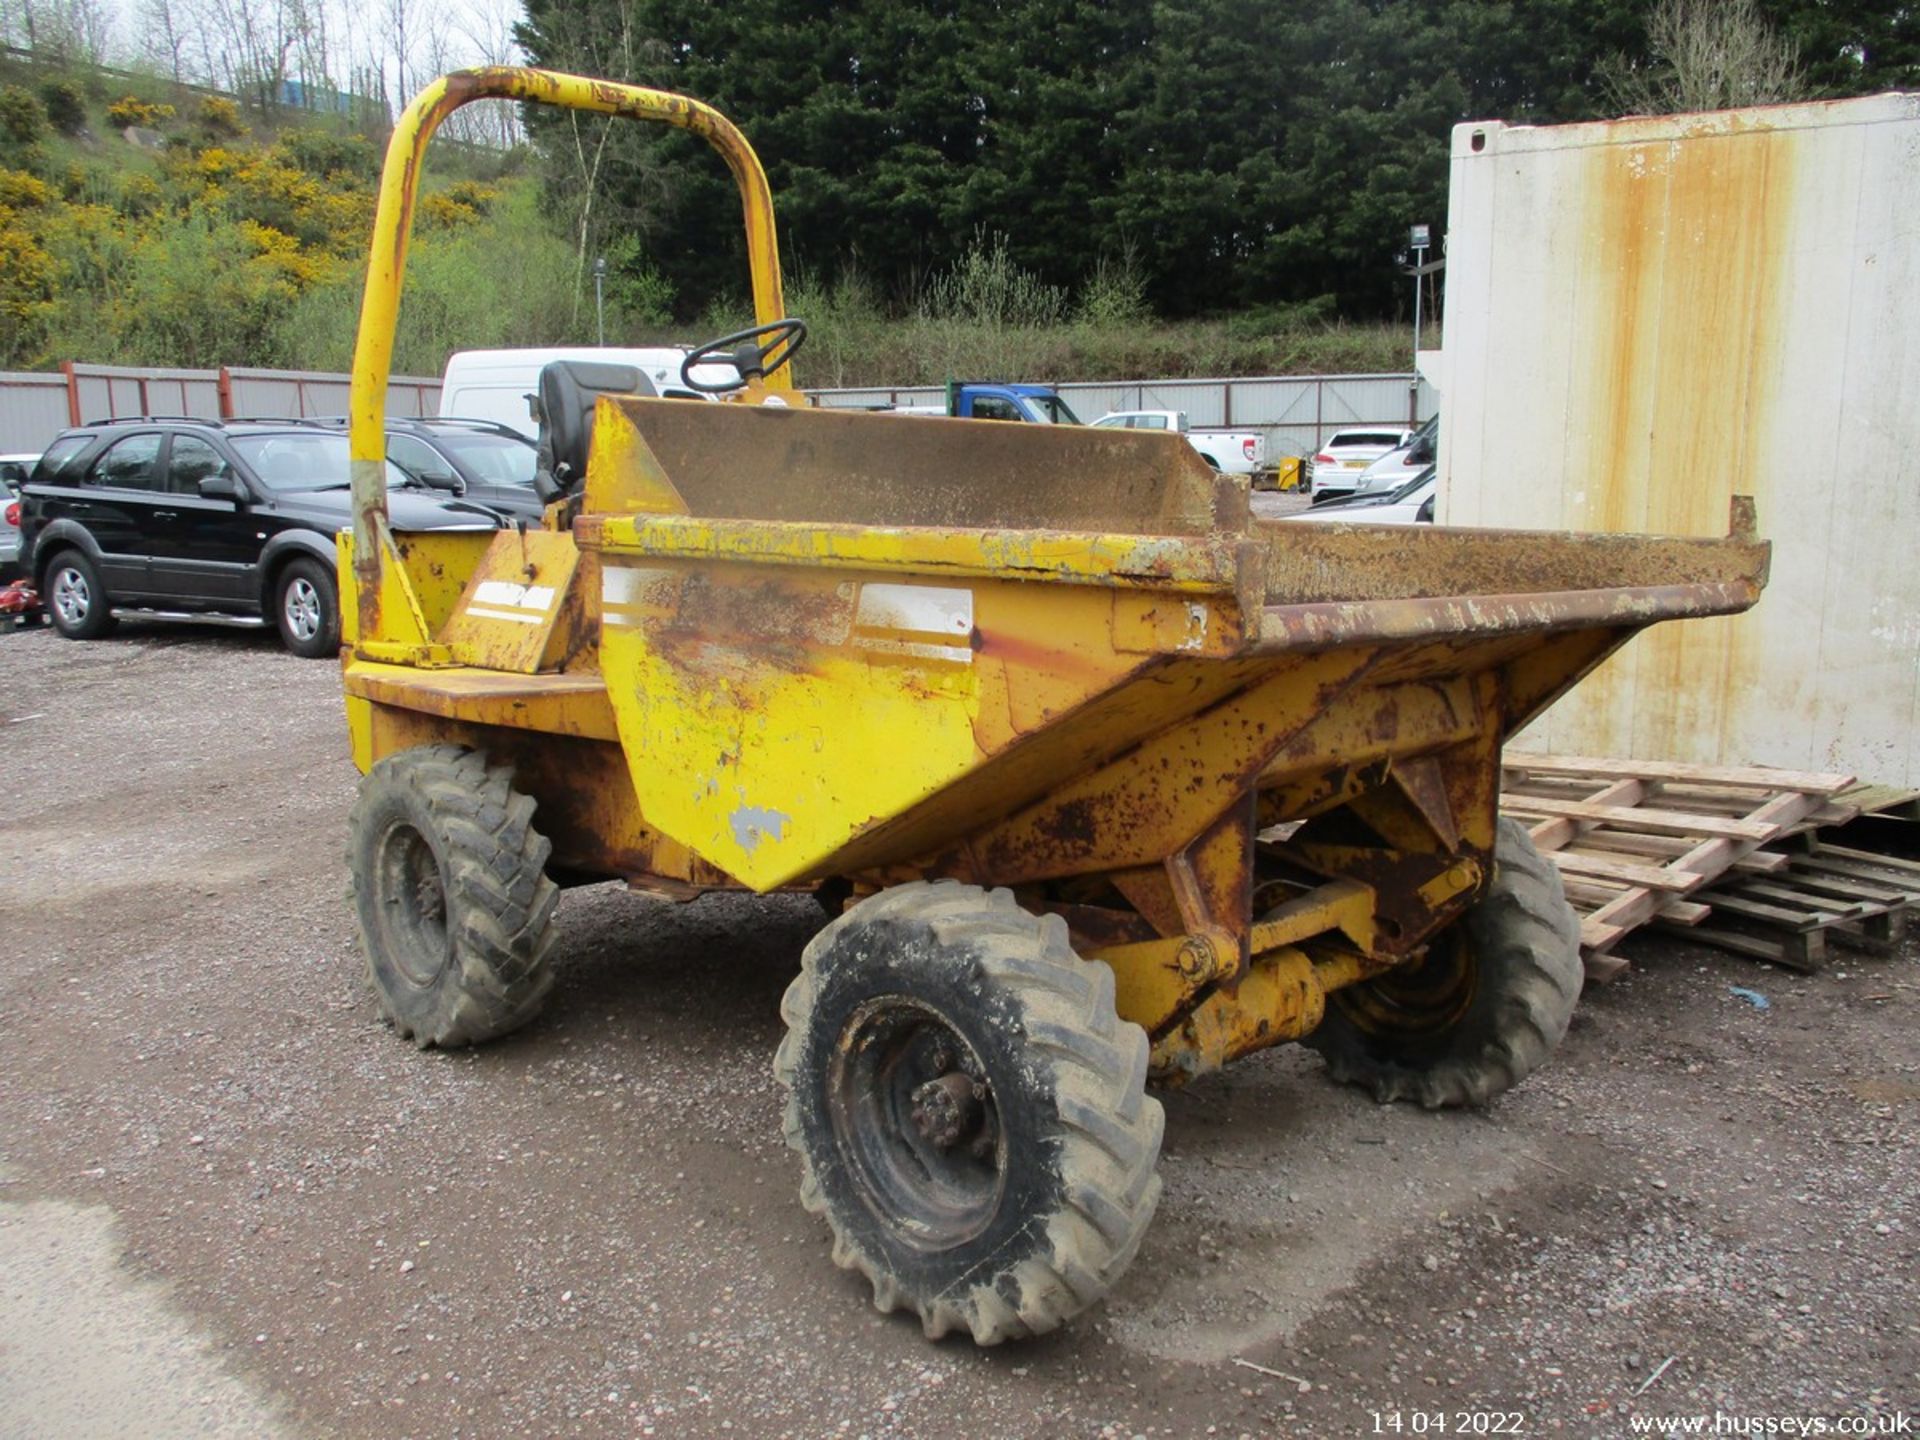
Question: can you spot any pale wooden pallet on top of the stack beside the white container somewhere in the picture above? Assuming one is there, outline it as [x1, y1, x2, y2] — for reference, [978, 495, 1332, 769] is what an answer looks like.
[1500, 755, 1853, 979]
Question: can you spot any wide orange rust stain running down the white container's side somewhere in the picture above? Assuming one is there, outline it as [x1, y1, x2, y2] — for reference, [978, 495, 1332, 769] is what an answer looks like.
[1553, 127, 1795, 758]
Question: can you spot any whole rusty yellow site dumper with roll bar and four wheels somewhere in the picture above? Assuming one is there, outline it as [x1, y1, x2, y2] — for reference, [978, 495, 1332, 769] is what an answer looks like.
[342, 69, 1766, 1344]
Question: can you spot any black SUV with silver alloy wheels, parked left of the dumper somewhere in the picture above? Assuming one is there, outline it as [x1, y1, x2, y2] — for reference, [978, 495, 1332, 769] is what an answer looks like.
[21, 419, 507, 659]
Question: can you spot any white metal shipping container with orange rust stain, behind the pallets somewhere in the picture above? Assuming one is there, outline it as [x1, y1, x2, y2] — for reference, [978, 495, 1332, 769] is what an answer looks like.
[1440, 94, 1920, 785]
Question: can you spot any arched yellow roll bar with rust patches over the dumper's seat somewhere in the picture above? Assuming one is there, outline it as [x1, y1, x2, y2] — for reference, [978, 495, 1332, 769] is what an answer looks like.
[348, 65, 793, 653]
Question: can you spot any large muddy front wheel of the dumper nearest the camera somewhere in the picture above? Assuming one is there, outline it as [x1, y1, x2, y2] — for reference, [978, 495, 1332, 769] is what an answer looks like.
[774, 883, 1162, 1344]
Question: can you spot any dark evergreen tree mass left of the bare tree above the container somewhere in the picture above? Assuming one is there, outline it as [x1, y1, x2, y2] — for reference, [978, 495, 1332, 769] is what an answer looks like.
[520, 0, 1666, 315]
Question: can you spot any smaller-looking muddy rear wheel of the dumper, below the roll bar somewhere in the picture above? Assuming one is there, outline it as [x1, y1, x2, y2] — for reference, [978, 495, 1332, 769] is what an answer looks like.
[348, 745, 561, 1046]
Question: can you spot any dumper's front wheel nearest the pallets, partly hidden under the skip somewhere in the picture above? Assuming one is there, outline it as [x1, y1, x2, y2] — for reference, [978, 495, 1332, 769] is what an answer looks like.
[1306, 820, 1582, 1110]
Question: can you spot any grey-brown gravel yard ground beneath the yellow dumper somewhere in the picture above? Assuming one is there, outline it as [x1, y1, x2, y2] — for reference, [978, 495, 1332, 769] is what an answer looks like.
[0, 626, 1920, 1436]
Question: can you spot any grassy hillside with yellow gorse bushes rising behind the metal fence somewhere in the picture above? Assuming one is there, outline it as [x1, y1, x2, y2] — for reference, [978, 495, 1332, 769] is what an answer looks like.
[0, 58, 1409, 386]
